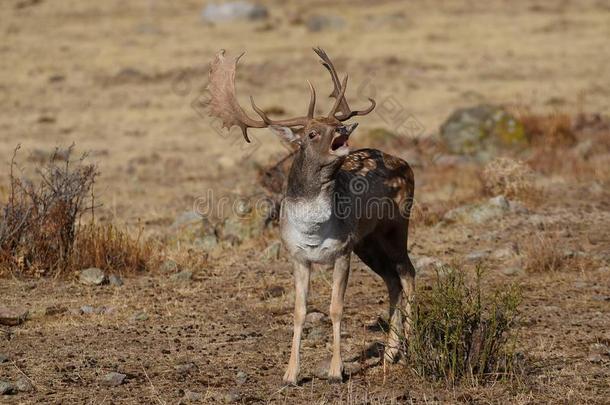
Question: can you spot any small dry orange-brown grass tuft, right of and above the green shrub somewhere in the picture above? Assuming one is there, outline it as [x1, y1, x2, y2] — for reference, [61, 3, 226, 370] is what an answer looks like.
[522, 233, 566, 273]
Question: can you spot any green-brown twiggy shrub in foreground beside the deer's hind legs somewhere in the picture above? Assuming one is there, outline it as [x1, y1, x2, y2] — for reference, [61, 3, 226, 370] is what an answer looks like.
[405, 267, 521, 385]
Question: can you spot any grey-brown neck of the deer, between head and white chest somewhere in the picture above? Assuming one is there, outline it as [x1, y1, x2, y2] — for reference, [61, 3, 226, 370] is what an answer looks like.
[286, 150, 341, 200]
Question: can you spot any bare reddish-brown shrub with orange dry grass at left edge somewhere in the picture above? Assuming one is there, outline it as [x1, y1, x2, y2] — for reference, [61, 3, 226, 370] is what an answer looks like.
[0, 146, 159, 276]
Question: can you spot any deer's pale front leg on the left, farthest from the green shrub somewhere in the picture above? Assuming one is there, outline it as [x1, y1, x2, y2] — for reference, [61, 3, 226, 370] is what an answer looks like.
[284, 262, 311, 385]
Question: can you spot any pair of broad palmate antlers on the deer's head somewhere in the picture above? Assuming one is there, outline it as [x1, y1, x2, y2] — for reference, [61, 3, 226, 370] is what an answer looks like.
[207, 48, 375, 142]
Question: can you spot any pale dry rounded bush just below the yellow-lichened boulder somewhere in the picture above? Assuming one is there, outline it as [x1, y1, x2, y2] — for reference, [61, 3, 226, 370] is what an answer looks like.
[482, 158, 540, 201]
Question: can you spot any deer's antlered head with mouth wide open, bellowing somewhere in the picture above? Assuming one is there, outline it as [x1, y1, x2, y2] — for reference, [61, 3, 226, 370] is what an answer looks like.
[208, 48, 375, 162]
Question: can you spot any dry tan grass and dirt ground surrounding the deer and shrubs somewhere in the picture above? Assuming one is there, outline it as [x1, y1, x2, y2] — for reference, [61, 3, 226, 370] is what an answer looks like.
[0, 0, 610, 404]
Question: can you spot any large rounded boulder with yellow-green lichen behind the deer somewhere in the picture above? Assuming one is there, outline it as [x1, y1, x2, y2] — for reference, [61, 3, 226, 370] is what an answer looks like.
[440, 104, 527, 161]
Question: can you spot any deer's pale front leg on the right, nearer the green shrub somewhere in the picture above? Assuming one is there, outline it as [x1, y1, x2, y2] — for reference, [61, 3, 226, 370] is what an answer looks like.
[328, 253, 350, 382]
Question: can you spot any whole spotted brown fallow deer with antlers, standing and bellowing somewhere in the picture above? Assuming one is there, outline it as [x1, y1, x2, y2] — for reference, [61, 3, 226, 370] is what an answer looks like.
[208, 48, 415, 384]
